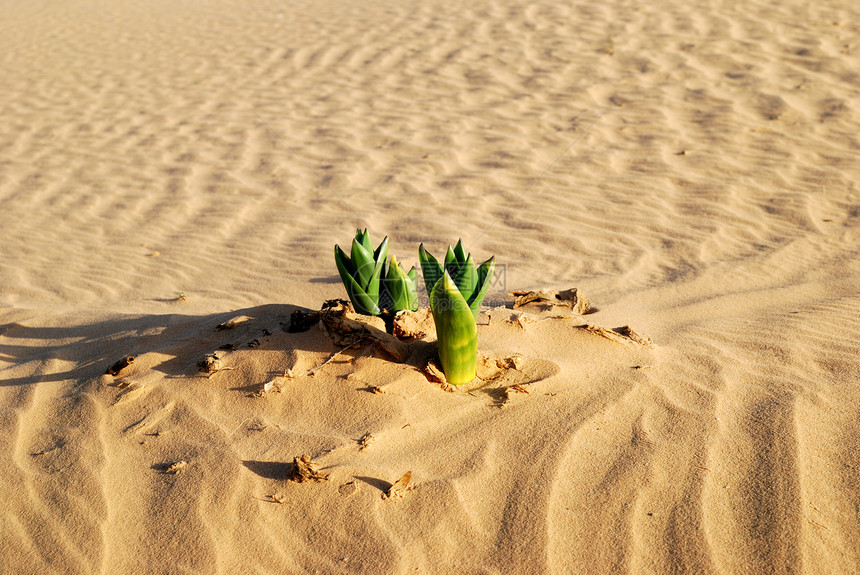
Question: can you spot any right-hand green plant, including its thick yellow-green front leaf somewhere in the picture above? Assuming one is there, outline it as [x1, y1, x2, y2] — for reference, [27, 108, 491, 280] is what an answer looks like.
[418, 240, 495, 385]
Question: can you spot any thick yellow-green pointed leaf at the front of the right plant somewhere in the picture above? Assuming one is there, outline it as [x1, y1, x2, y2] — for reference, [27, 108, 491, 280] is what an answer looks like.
[430, 272, 478, 385]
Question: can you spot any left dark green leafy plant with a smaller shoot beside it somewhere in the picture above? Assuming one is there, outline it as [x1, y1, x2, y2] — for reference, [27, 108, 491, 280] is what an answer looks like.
[334, 230, 418, 315]
